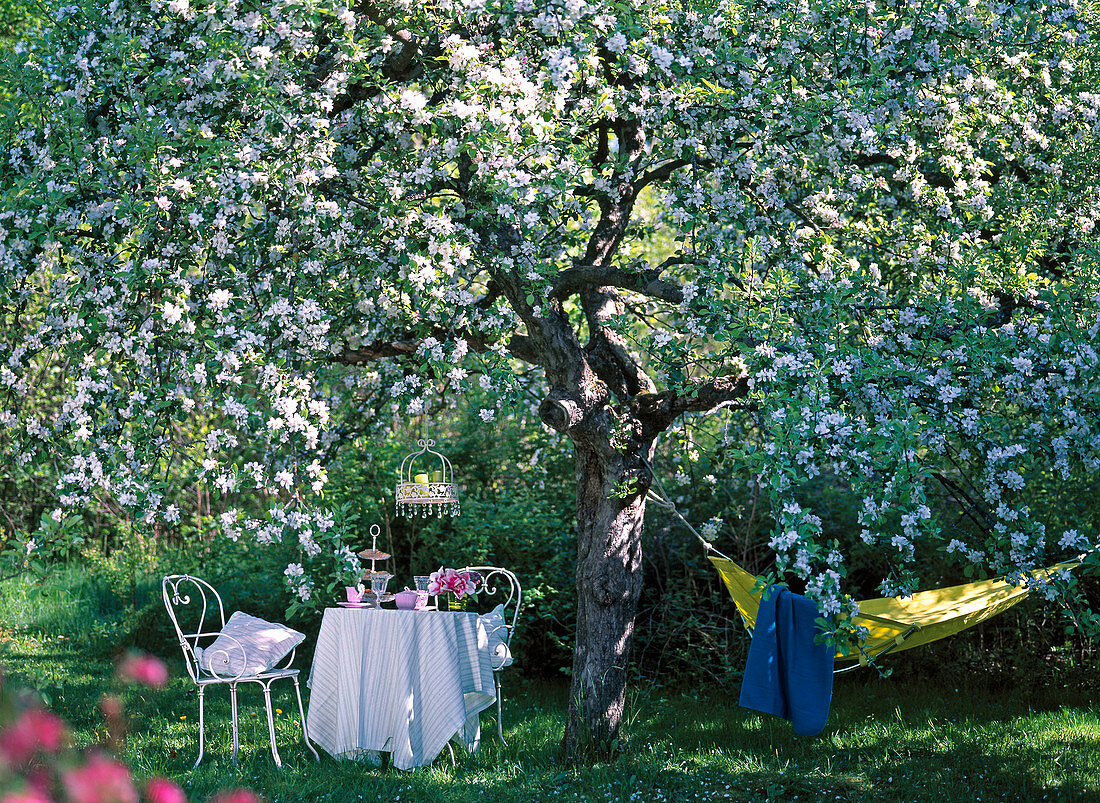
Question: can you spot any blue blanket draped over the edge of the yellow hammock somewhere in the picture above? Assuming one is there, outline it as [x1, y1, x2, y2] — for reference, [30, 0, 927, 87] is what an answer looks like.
[740, 586, 834, 736]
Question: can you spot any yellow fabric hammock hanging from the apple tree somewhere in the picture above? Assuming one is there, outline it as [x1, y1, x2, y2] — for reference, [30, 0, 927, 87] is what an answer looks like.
[707, 556, 1080, 668]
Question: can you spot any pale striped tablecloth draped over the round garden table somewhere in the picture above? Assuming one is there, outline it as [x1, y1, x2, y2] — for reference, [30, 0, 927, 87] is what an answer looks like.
[306, 608, 496, 770]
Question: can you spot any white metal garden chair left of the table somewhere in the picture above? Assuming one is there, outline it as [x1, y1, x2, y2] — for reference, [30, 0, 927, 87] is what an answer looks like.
[161, 574, 320, 767]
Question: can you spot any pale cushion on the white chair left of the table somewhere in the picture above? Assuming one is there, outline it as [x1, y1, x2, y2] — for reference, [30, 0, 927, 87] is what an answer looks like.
[198, 611, 306, 678]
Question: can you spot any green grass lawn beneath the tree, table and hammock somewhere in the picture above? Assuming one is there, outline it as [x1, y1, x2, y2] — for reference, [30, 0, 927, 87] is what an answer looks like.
[3, 626, 1100, 803]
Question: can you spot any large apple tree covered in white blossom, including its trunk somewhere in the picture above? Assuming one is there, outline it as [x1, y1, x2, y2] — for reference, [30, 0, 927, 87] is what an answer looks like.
[0, 0, 1100, 758]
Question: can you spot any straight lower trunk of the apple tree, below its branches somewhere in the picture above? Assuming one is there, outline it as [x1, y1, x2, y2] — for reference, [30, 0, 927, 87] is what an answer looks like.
[562, 431, 652, 763]
